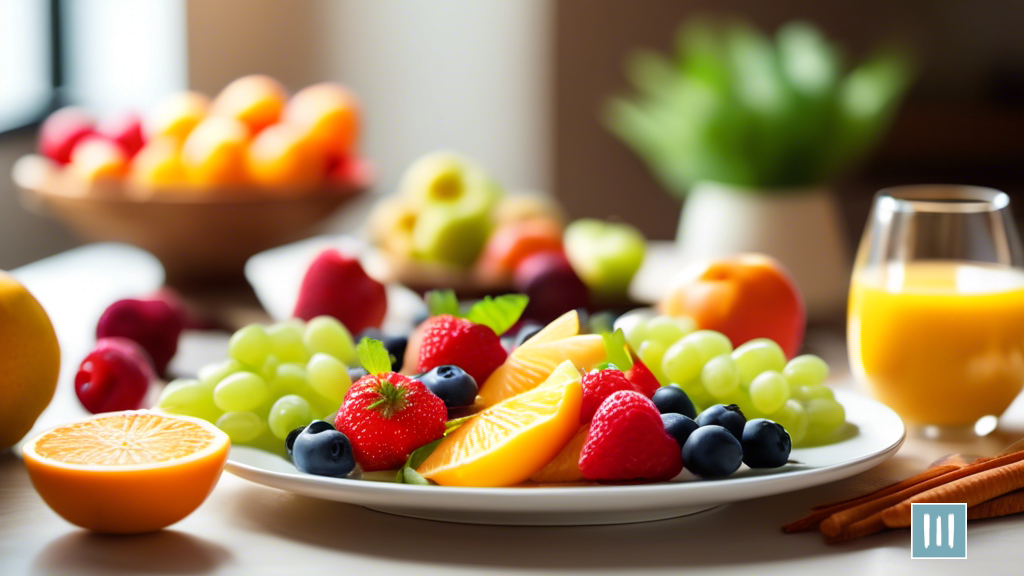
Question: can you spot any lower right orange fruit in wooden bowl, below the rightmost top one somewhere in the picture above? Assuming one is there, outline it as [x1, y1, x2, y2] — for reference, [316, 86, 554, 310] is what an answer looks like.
[246, 124, 327, 189]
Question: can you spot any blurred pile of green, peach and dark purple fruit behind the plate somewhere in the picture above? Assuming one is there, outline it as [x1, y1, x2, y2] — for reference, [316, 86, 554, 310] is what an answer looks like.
[368, 151, 645, 322]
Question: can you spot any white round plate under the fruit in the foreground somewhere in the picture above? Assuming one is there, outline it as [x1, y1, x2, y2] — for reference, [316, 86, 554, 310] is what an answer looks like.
[227, 390, 905, 526]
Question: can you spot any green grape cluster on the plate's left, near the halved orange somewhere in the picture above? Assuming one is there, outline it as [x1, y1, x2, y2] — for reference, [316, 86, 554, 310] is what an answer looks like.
[158, 316, 358, 452]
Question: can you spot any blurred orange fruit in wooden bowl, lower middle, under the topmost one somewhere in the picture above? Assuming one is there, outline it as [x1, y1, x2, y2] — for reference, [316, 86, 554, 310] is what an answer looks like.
[181, 116, 249, 187]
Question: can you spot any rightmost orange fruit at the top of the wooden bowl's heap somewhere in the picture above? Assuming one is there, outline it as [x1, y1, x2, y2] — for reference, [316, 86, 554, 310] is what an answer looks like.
[282, 82, 359, 158]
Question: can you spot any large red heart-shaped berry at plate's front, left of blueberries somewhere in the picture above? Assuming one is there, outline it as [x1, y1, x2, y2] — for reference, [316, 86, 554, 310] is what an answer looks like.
[580, 390, 683, 482]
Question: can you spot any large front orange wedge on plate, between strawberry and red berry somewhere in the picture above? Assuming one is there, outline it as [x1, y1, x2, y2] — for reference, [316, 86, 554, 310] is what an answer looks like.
[417, 361, 583, 486]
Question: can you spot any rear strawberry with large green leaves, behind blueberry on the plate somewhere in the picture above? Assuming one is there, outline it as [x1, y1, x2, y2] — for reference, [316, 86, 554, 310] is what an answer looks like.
[417, 291, 528, 387]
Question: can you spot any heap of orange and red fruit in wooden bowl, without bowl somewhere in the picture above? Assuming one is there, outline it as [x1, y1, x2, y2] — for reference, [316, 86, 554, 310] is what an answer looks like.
[25, 75, 370, 198]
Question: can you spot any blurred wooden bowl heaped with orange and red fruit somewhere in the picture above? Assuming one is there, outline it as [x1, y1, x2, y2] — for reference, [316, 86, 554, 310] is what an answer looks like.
[13, 75, 372, 281]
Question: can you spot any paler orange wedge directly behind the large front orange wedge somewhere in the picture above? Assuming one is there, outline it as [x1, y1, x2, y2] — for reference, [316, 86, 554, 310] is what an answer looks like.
[478, 311, 606, 406]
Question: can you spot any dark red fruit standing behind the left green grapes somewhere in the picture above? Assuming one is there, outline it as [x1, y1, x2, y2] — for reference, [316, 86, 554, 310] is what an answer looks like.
[293, 249, 387, 334]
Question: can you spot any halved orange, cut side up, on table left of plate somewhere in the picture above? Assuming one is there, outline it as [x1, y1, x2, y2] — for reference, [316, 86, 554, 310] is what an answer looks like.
[23, 410, 230, 534]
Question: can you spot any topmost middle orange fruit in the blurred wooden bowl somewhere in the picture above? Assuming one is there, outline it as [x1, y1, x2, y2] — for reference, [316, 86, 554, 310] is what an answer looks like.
[210, 74, 288, 134]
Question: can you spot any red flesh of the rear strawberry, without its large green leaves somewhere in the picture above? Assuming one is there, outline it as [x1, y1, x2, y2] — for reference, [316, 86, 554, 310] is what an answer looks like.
[417, 314, 508, 387]
